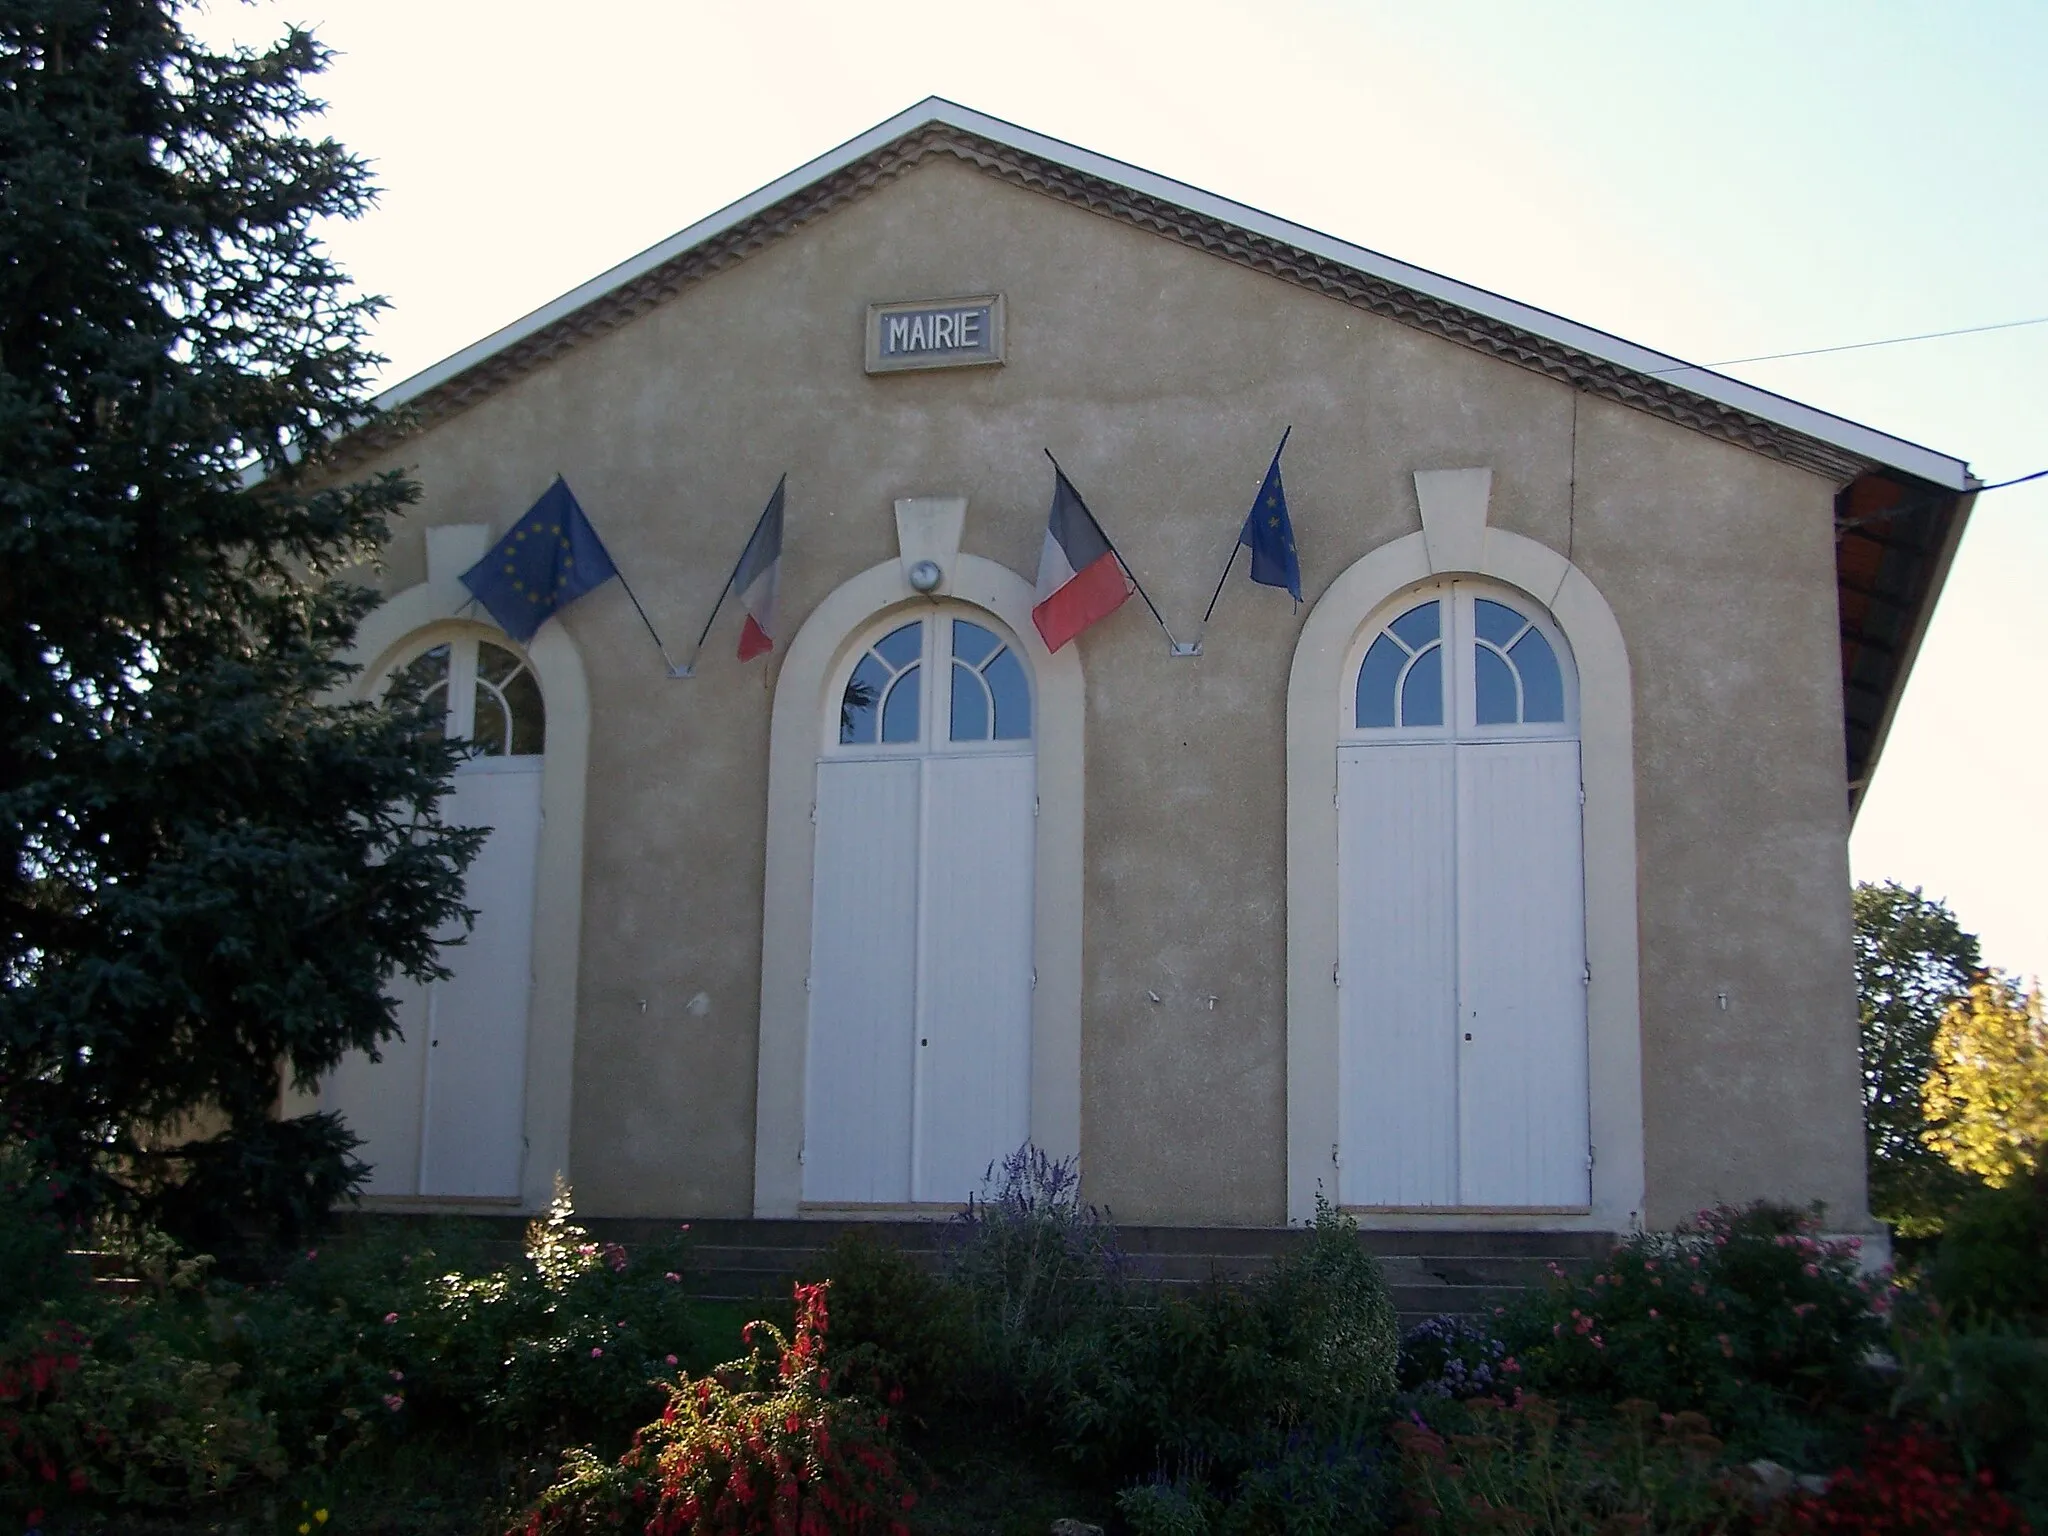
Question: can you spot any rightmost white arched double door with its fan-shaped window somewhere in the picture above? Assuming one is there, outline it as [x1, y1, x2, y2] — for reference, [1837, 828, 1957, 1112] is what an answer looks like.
[1337, 580, 1591, 1210]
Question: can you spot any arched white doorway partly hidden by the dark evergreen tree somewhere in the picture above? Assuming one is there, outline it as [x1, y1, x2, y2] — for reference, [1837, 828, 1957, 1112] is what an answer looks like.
[319, 629, 547, 1200]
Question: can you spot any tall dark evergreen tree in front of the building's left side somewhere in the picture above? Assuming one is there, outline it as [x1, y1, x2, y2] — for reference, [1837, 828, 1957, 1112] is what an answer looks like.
[0, 0, 477, 1225]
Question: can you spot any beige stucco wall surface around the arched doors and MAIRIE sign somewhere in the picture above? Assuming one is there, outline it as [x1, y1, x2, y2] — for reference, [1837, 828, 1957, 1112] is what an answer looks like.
[339, 162, 1864, 1225]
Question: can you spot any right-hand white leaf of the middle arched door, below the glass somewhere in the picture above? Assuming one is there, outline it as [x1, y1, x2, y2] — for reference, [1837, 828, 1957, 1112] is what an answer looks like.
[913, 756, 1036, 1202]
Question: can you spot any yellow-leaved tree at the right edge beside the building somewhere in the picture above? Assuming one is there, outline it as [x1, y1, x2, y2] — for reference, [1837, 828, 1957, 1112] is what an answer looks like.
[1921, 975, 2048, 1184]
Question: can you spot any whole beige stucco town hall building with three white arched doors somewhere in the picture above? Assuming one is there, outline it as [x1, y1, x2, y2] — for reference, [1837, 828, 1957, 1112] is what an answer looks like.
[296, 102, 1976, 1253]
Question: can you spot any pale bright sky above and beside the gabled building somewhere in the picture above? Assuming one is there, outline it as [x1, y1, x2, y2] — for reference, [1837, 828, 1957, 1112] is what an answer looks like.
[199, 0, 2048, 975]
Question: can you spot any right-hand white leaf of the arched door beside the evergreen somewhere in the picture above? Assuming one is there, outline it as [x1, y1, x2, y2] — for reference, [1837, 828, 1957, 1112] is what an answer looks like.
[420, 760, 541, 1196]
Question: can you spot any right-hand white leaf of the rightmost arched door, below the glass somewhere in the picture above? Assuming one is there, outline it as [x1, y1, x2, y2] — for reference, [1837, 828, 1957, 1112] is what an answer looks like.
[1456, 741, 1591, 1206]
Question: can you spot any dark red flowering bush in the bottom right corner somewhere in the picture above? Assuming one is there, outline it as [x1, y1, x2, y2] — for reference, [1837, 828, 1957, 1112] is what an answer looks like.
[1778, 1430, 2028, 1536]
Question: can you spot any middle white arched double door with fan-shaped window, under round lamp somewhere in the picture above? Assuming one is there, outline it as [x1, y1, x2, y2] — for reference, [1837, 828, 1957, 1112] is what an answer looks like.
[801, 604, 1036, 1206]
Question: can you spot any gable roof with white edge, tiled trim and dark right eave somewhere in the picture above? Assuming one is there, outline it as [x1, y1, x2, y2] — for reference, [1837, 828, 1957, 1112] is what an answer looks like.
[358, 96, 1978, 801]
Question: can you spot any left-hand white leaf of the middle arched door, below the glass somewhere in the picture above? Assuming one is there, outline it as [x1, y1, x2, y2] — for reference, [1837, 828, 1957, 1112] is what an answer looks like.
[803, 760, 920, 1204]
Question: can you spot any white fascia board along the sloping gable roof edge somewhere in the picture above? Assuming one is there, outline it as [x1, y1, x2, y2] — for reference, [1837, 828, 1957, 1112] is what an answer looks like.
[377, 96, 1976, 492]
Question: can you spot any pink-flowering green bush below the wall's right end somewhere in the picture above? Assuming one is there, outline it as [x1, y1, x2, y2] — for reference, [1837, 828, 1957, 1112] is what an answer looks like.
[1499, 1204, 1888, 1423]
